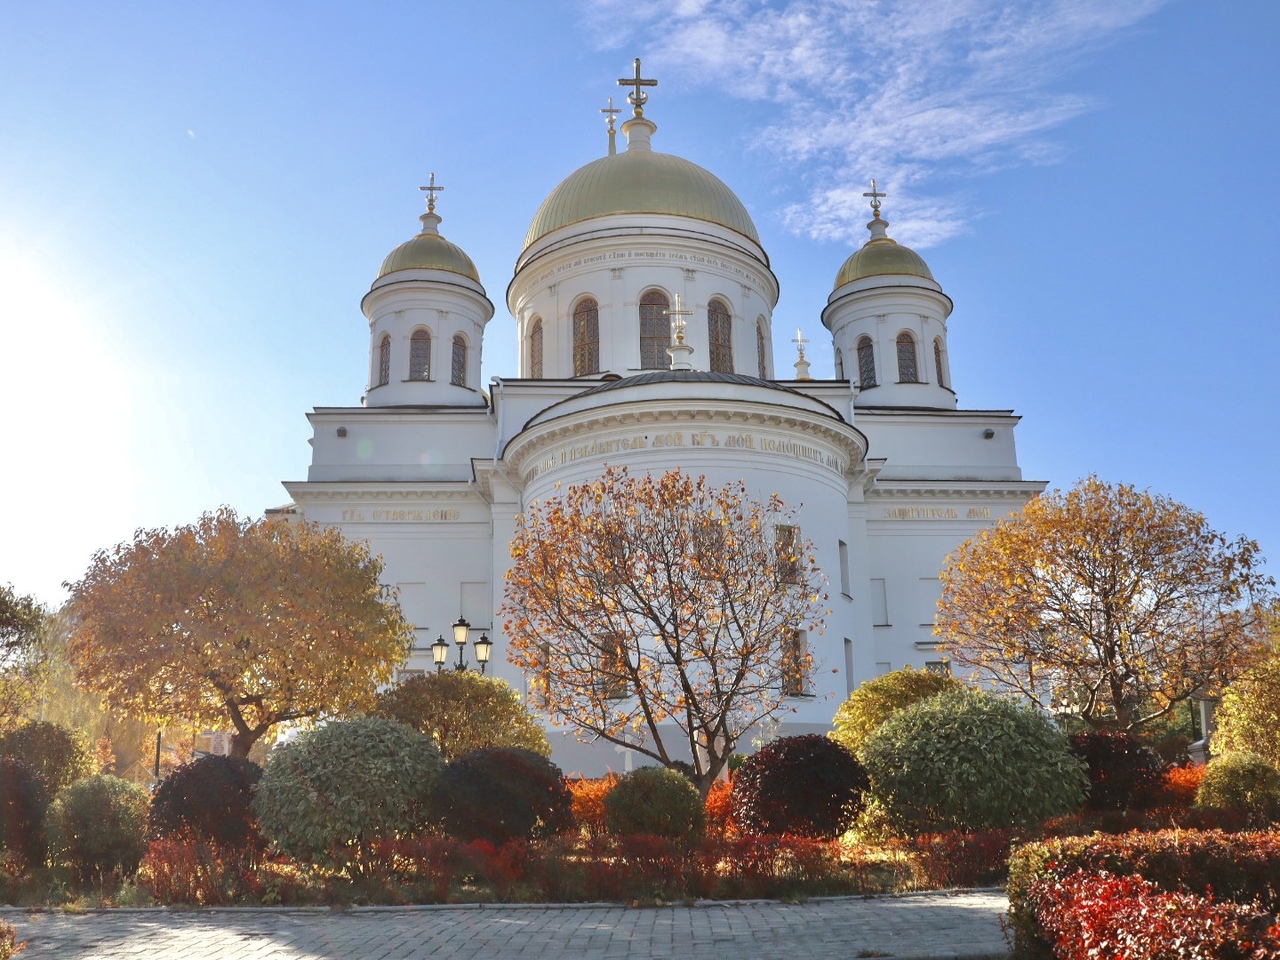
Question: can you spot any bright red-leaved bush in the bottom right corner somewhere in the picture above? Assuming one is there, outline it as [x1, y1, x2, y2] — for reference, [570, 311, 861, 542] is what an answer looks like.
[1027, 870, 1280, 960]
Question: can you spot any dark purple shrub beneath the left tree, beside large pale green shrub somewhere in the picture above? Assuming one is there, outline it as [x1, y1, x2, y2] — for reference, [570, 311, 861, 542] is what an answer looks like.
[151, 756, 262, 850]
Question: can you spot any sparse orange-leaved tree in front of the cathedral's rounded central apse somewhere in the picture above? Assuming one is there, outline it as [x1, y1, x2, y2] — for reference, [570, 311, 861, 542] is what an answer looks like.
[502, 468, 824, 795]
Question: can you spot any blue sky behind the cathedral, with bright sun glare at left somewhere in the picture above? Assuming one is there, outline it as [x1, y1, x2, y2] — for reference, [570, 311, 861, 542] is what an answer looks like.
[0, 0, 1280, 603]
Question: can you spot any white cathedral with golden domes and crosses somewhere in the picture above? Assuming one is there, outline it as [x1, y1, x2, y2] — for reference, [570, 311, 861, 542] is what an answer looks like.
[282, 60, 1044, 776]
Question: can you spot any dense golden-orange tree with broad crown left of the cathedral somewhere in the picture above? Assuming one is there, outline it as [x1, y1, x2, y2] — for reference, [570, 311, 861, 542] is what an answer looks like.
[69, 508, 411, 756]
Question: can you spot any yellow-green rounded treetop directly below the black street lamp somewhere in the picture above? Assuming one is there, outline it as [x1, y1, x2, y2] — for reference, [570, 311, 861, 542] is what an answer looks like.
[372, 669, 552, 760]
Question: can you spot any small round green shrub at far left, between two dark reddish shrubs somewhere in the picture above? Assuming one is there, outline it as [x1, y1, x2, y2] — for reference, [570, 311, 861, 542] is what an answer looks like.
[45, 773, 150, 886]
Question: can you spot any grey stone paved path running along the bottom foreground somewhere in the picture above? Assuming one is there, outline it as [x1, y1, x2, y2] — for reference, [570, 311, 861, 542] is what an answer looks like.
[0, 891, 1007, 960]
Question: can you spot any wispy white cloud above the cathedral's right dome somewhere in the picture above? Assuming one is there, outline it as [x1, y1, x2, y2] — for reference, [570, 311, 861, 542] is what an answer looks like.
[584, 0, 1170, 247]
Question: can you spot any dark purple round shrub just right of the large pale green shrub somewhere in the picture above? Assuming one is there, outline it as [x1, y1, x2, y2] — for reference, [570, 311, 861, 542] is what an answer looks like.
[435, 746, 573, 846]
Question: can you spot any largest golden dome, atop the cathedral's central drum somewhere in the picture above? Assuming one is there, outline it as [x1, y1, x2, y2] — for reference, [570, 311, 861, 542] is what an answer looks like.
[525, 120, 760, 250]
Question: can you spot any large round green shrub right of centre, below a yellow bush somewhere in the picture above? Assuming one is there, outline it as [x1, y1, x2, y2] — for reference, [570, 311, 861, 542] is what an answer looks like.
[861, 690, 1088, 833]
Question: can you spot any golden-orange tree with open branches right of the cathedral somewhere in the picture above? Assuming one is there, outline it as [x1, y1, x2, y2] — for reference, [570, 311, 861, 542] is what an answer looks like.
[936, 476, 1275, 731]
